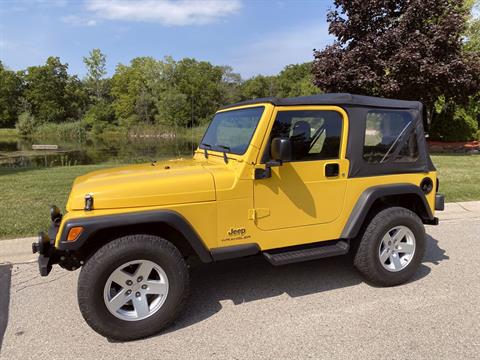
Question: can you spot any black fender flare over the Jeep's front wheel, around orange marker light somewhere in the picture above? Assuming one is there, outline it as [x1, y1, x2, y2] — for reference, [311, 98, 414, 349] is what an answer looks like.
[58, 210, 212, 263]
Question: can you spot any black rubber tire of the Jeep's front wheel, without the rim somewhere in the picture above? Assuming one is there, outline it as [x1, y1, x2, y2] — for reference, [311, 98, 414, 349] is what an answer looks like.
[77, 235, 189, 341]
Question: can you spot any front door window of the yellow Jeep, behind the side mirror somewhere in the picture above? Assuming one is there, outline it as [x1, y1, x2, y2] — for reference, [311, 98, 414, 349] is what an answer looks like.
[268, 110, 342, 161]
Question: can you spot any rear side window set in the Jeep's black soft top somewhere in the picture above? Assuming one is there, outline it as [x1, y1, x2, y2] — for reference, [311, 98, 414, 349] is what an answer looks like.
[363, 110, 418, 163]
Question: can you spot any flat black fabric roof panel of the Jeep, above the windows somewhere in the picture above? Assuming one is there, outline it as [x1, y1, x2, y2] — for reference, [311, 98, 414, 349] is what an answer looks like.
[222, 93, 423, 113]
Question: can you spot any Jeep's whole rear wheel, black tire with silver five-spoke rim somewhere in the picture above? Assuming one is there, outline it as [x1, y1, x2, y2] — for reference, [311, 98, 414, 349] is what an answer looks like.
[354, 207, 425, 286]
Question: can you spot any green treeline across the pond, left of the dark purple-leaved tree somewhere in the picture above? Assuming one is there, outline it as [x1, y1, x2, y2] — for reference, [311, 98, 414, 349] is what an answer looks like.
[0, 49, 319, 137]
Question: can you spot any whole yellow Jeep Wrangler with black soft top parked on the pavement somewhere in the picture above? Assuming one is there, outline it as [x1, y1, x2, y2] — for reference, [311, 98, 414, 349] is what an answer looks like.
[33, 94, 444, 340]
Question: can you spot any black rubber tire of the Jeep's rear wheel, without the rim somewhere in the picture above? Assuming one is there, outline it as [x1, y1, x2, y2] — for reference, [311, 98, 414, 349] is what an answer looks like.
[354, 207, 426, 286]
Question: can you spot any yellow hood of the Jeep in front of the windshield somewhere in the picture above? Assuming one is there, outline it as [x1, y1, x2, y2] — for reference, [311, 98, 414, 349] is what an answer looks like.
[67, 160, 215, 211]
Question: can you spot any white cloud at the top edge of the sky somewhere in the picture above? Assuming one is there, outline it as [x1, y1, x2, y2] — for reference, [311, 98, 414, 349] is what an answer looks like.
[87, 0, 241, 26]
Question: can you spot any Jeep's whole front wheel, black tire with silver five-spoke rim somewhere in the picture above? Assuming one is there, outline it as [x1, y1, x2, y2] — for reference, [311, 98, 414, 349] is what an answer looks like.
[78, 235, 189, 341]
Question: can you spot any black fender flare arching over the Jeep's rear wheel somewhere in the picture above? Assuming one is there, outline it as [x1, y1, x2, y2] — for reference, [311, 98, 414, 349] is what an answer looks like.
[340, 184, 434, 239]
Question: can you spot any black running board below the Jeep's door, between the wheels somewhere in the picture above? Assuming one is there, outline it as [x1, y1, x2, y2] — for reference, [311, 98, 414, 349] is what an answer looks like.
[263, 240, 350, 266]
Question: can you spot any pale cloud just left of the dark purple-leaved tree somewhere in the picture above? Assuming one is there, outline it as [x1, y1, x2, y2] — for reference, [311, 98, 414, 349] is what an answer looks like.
[229, 22, 333, 78]
